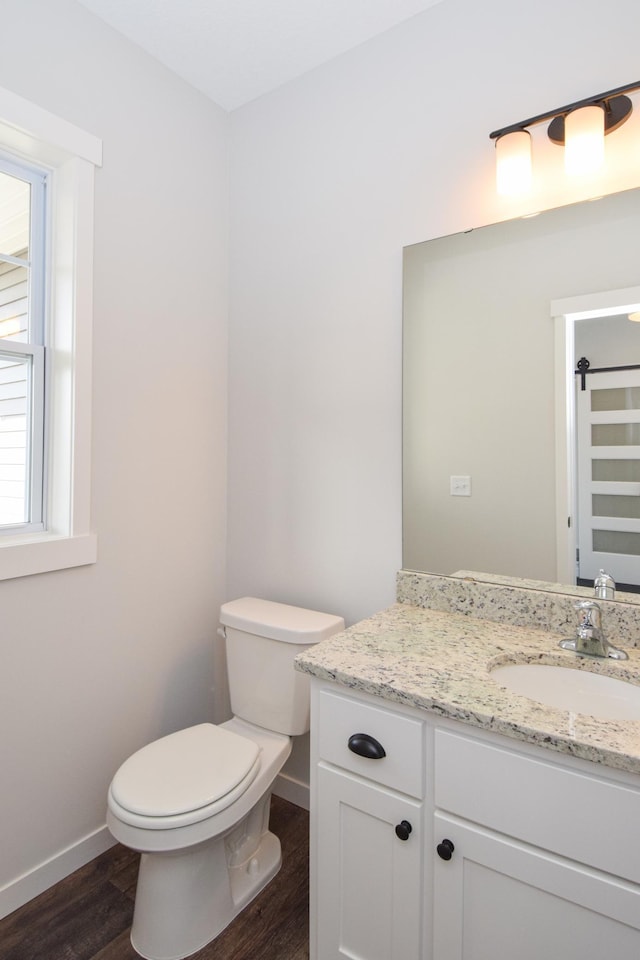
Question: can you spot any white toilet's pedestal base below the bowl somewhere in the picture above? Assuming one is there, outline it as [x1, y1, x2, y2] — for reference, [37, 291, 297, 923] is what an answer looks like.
[131, 797, 282, 960]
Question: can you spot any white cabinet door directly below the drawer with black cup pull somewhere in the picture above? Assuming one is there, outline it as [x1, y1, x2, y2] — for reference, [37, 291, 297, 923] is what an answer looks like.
[315, 764, 423, 960]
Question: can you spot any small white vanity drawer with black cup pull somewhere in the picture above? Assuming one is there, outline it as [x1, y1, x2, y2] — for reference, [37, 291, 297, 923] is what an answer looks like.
[318, 690, 425, 798]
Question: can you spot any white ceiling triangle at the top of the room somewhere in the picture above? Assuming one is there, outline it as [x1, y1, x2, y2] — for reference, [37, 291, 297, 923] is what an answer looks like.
[79, 0, 442, 110]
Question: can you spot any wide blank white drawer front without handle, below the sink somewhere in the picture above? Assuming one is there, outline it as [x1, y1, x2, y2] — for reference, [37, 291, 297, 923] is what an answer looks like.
[434, 730, 640, 883]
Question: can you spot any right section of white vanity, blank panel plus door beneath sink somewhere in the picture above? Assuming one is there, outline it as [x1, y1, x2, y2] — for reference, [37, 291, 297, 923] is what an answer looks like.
[433, 729, 640, 960]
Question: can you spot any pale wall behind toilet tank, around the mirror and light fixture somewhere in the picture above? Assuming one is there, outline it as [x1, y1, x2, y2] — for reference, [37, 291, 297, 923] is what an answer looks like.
[228, 0, 640, 621]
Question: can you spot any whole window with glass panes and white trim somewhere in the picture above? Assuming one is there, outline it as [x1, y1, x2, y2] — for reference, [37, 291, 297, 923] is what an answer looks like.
[0, 88, 102, 579]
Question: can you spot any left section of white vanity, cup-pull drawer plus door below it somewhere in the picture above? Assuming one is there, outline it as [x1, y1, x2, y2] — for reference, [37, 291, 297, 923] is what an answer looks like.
[311, 689, 425, 960]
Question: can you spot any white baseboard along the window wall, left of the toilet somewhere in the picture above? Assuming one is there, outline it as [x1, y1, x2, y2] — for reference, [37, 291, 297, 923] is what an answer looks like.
[0, 826, 116, 919]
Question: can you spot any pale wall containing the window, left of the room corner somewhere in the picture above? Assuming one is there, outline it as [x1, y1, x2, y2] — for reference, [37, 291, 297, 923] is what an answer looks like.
[0, 0, 228, 909]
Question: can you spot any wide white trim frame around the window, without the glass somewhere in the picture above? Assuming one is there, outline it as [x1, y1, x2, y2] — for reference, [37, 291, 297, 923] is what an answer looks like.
[0, 88, 102, 580]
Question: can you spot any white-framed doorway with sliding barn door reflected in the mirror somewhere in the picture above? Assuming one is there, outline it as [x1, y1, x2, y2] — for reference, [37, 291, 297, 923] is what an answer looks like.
[552, 287, 640, 592]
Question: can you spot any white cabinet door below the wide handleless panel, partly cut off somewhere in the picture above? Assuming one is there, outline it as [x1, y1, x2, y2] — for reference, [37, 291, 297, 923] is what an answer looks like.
[433, 814, 640, 960]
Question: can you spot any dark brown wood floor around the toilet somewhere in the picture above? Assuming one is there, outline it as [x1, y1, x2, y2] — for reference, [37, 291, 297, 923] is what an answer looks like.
[0, 797, 309, 960]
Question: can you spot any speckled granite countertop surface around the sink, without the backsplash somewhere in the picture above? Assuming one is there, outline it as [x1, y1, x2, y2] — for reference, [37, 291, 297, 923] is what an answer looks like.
[296, 603, 640, 774]
